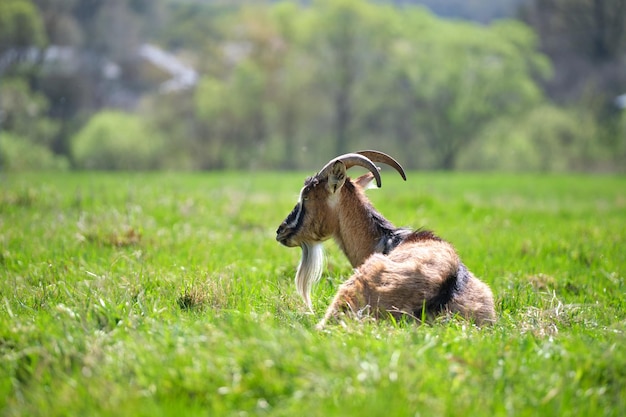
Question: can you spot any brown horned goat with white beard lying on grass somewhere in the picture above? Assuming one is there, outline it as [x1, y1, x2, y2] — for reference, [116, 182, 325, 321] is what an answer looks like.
[276, 151, 496, 329]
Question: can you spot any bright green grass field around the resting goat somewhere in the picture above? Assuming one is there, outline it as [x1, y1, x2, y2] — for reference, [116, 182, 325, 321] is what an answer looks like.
[0, 170, 626, 417]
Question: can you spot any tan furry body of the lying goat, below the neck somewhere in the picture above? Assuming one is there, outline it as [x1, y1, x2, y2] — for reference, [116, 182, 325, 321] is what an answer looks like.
[320, 232, 495, 324]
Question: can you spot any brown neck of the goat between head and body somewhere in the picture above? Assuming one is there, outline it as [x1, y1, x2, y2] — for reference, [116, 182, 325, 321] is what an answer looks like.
[334, 184, 395, 268]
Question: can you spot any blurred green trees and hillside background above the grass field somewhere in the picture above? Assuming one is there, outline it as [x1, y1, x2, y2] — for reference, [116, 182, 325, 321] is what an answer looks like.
[0, 0, 626, 172]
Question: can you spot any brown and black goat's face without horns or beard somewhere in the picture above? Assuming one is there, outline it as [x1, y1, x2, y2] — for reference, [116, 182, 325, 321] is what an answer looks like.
[276, 176, 338, 247]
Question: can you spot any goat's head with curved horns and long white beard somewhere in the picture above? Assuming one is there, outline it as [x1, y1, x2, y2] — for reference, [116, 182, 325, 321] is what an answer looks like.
[276, 151, 406, 308]
